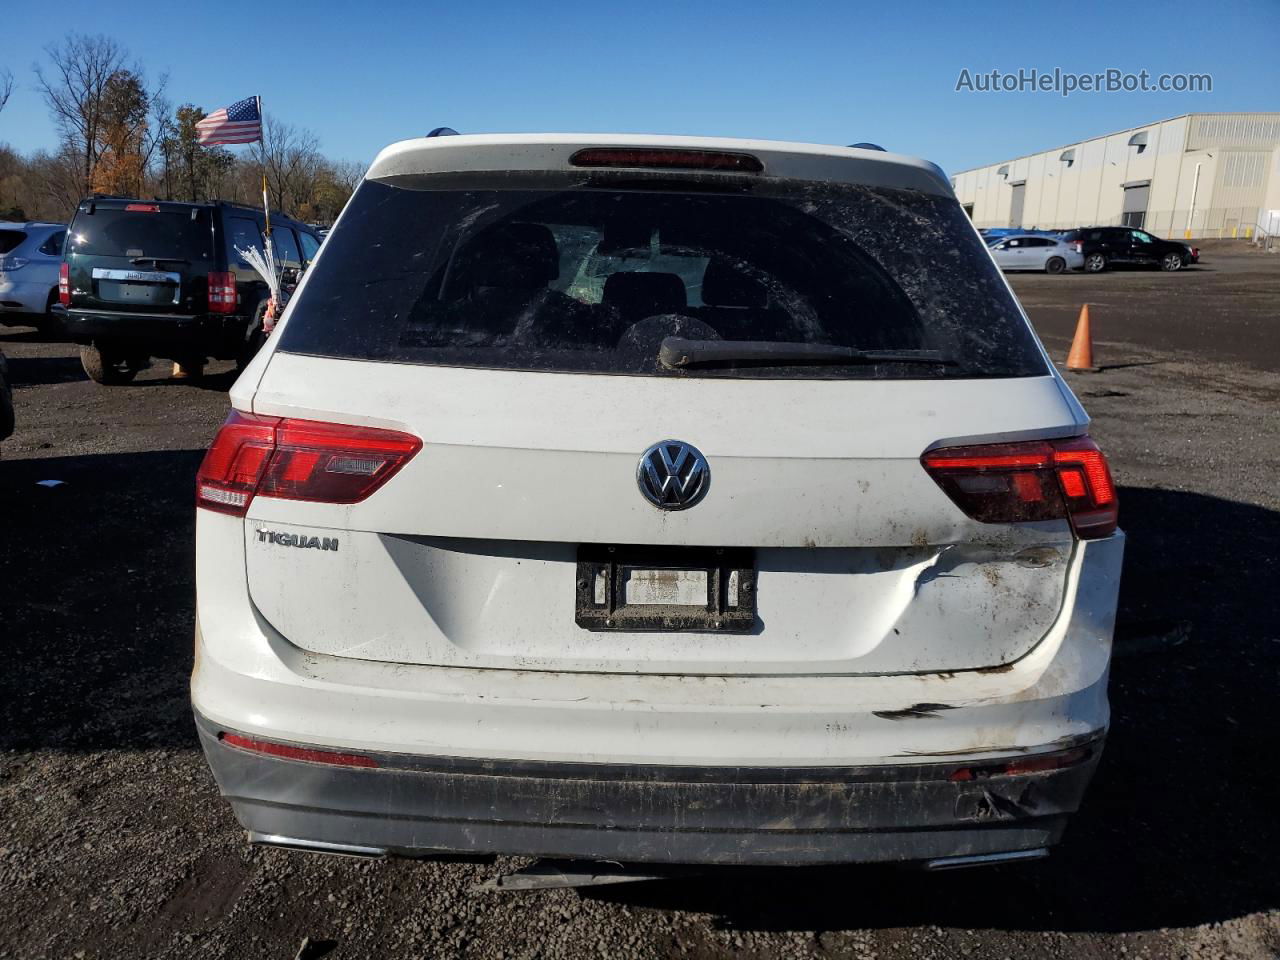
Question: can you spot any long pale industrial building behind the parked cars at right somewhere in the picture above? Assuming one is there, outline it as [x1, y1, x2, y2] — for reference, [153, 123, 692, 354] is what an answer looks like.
[952, 113, 1280, 238]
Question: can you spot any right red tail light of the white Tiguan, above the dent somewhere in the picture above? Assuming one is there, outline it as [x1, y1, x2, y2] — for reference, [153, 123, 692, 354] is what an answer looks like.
[920, 436, 1119, 540]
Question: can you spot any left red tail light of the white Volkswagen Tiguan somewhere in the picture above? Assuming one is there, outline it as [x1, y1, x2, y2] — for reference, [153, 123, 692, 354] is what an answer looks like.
[196, 411, 422, 517]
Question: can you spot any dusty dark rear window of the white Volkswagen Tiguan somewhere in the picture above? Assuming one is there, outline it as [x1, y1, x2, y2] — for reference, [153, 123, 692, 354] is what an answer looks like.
[280, 174, 1046, 378]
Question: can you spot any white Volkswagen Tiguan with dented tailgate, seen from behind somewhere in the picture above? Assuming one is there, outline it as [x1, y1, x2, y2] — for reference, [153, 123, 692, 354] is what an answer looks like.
[192, 134, 1123, 867]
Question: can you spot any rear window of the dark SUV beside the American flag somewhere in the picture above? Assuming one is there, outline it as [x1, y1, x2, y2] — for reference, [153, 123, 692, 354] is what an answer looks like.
[67, 205, 214, 261]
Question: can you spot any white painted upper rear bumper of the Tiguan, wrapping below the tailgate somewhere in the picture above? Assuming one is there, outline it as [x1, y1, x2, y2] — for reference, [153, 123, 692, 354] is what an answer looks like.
[192, 511, 1124, 765]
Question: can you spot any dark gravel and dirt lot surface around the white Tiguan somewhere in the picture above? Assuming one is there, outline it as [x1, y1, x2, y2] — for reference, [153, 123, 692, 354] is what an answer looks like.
[0, 246, 1280, 960]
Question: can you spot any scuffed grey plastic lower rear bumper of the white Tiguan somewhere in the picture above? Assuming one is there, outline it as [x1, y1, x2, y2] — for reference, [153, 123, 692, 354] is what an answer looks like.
[196, 713, 1102, 865]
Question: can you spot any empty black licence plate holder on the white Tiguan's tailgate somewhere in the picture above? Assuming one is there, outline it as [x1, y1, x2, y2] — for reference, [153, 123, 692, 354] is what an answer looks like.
[575, 544, 755, 632]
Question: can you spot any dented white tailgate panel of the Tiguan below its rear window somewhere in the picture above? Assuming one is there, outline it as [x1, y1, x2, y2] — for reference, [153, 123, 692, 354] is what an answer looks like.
[244, 355, 1083, 675]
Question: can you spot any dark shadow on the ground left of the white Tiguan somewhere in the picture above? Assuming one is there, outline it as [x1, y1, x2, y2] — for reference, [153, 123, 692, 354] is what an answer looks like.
[0, 450, 204, 750]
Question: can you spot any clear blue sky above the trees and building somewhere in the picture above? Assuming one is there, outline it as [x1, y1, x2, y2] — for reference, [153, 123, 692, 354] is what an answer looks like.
[0, 0, 1280, 172]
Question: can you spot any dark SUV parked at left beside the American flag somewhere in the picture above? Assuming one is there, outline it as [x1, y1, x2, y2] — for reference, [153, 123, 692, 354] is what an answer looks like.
[59, 196, 320, 384]
